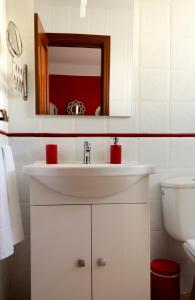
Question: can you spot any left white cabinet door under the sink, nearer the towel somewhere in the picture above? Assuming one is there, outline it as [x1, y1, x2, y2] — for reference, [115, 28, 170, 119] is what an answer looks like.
[31, 205, 91, 300]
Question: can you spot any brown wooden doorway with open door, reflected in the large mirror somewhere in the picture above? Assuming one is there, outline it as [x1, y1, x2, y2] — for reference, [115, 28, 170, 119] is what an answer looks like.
[35, 14, 110, 115]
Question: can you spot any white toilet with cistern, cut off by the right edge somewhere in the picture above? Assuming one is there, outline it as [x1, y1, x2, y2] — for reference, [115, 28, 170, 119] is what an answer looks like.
[161, 177, 195, 300]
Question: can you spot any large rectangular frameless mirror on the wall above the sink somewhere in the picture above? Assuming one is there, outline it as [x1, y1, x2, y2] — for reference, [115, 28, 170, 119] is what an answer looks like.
[34, 0, 133, 116]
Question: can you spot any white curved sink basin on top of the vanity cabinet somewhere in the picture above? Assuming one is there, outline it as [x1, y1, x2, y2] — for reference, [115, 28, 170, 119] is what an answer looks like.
[23, 163, 154, 198]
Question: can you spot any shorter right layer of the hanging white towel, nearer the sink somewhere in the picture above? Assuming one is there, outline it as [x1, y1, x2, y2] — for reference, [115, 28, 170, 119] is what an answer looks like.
[2, 145, 24, 245]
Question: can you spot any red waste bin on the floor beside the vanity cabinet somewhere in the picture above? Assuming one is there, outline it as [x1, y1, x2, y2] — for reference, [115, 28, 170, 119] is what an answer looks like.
[151, 259, 180, 300]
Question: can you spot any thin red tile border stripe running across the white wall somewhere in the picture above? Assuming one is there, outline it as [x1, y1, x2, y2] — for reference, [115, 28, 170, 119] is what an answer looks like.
[0, 130, 195, 138]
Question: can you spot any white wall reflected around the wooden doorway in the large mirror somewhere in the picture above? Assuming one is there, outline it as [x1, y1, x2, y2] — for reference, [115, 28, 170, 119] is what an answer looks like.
[34, 0, 134, 116]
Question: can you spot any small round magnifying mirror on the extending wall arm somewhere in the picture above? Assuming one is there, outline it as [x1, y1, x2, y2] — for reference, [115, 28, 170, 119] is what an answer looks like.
[7, 21, 22, 57]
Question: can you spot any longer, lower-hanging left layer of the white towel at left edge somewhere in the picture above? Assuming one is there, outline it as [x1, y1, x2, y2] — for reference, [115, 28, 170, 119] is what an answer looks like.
[0, 147, 14, 259]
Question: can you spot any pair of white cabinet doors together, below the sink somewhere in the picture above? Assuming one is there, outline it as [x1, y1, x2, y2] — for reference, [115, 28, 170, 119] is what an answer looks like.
[31, 199, 149, 300]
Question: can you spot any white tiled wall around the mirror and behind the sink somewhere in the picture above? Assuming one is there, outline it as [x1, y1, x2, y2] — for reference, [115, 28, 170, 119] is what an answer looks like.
[1, 0, 195, 300]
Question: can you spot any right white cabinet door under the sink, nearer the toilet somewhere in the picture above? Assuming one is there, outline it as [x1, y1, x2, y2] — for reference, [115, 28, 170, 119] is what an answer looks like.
[92, 204, 150, 300]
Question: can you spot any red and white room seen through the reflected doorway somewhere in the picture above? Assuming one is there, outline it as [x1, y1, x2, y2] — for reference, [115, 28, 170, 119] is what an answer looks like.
[48, 47, 102, 115]
